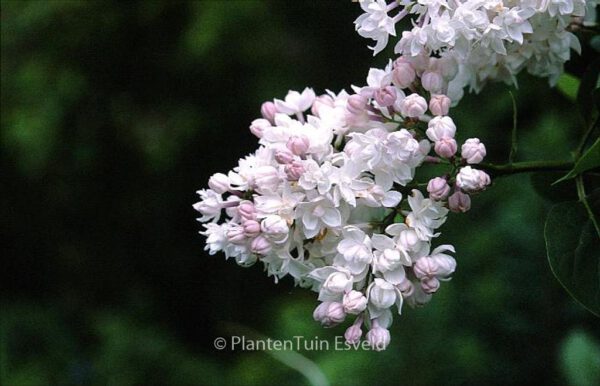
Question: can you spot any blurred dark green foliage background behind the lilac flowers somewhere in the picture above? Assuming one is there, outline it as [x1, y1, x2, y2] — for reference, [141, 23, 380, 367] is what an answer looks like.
[0, 0, 600, 386]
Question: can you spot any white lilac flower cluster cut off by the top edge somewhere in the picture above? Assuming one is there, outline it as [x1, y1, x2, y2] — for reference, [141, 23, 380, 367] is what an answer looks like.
[355, 0, 595, 99]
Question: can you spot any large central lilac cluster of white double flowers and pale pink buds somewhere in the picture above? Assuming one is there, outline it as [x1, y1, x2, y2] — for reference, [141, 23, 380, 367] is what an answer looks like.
[194, 51, 490, 350]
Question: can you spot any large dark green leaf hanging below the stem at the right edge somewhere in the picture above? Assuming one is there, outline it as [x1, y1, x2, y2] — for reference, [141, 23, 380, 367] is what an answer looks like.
[544, 190, 600, 316]
